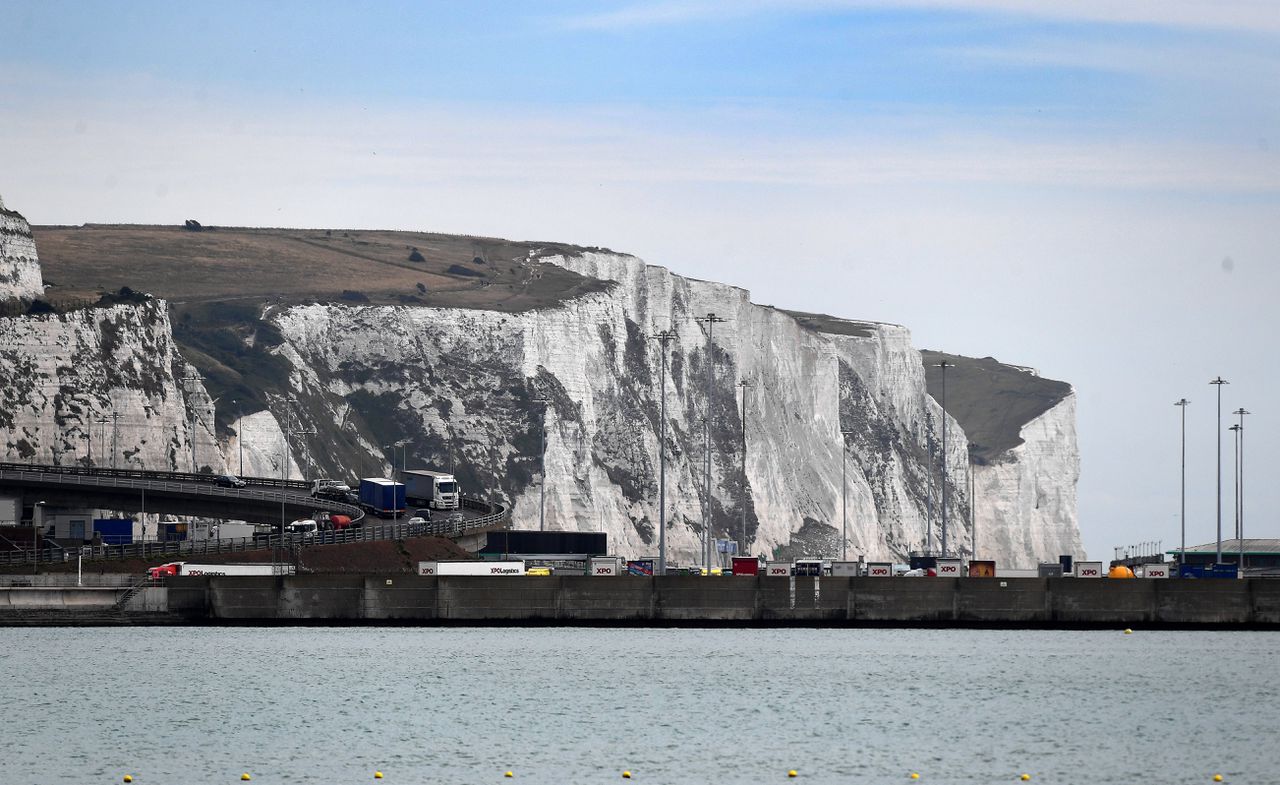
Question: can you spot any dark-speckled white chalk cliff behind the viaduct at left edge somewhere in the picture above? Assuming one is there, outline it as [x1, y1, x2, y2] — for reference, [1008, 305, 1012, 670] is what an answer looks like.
[0, 301, 223, 471]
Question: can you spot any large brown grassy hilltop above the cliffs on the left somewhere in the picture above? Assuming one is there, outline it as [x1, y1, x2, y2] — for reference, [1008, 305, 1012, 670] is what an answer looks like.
[33, 224, 608, 311]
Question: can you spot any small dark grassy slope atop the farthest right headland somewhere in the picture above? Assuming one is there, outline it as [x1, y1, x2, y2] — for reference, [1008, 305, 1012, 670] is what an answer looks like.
[920, 350, 1071, 464]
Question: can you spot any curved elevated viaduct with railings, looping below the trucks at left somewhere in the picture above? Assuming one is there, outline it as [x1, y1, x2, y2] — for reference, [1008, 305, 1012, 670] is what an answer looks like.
[0, 464, 507, 566]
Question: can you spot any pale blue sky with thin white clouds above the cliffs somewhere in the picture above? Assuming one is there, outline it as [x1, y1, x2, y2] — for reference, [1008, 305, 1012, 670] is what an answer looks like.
[0, 0, 1280, 560]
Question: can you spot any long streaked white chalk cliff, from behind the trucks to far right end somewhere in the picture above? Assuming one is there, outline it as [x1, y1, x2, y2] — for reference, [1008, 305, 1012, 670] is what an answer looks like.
[264, 252, 1079, 563]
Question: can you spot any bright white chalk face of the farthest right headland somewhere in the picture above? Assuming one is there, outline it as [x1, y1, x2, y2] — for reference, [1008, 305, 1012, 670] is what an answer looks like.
[974, 393, 1084, 567]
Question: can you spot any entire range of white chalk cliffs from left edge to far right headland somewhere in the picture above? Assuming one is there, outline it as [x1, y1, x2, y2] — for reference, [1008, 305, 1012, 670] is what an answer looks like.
[0, 194, 1083, 566]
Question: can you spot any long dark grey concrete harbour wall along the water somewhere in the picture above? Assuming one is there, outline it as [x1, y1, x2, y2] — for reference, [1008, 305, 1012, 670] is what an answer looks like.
[0, 574, 1280, 629]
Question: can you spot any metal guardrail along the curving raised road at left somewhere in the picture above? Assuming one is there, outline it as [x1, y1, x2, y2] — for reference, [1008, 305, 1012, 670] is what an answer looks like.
[0, 462, 507, 565]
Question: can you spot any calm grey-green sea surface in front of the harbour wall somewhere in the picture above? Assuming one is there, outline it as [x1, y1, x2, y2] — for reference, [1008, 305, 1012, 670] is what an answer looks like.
[0, 629, 1280, 785]
